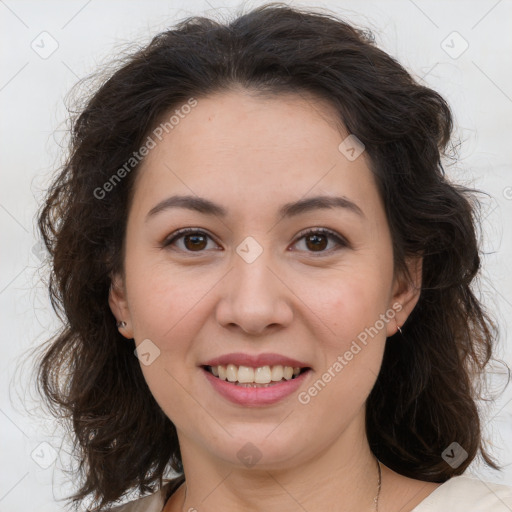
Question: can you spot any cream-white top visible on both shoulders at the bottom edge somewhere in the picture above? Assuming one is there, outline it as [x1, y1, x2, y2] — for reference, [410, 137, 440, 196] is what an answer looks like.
[112, 475, 512, 512]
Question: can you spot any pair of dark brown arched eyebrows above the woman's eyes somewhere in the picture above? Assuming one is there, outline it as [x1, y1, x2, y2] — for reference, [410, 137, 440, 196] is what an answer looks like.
[146, 196, 365, 222]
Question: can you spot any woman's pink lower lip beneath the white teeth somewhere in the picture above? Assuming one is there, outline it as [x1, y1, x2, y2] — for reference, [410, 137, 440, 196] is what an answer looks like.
[202, 368, 310, 407]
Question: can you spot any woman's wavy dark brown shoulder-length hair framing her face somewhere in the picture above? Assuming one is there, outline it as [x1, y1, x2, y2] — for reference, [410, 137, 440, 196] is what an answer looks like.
[36, 4, 499, 510]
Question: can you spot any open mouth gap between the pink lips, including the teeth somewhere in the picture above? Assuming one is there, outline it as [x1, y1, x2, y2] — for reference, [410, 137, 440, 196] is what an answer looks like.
[202, 364, 311, 388]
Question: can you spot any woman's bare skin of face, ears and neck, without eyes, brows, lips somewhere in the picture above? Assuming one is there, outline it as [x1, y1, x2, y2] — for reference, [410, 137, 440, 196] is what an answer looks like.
[109, 90, 439, 512]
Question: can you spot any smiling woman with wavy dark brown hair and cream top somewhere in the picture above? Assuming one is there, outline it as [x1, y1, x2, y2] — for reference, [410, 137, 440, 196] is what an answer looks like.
[35, 4, 512, 512]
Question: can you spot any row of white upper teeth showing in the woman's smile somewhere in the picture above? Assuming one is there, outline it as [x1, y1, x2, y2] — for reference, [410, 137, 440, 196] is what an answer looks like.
[208, 364, 301, 384]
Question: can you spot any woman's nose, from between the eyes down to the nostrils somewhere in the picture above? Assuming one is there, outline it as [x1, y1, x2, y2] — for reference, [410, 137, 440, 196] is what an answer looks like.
[216, 251, 293, 335]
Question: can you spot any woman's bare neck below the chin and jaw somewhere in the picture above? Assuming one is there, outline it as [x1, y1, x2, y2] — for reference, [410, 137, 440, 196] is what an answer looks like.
[176, 416, 379, 512]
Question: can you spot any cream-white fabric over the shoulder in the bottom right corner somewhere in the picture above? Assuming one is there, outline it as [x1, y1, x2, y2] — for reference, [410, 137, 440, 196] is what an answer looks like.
[411, 475, 512, 512]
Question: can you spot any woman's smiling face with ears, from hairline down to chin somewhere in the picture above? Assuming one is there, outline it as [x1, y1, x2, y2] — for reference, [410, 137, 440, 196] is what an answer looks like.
[110, 91, 418, 468]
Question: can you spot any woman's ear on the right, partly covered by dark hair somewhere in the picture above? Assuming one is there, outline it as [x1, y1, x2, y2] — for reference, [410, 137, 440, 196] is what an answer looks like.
[387, 256, 423, 337]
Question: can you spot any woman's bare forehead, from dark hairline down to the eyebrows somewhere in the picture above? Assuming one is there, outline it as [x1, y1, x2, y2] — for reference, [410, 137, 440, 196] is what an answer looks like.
[130, 91, 378, 220]
